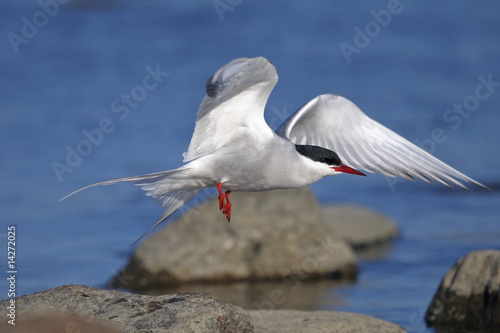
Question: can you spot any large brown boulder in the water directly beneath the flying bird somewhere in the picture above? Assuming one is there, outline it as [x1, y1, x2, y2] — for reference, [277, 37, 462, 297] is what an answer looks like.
[111, 188, 357, 290]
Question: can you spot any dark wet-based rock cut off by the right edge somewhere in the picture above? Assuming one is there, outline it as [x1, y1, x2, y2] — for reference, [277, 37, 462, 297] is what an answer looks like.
[425, 250, 500, 329]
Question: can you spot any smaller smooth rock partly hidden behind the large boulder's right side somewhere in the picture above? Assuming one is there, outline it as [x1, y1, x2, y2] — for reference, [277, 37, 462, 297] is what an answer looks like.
[323, 205, 399, 249]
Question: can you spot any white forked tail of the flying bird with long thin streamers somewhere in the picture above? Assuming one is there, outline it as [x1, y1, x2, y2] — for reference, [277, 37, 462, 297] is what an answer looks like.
[59, 167, 202, 244]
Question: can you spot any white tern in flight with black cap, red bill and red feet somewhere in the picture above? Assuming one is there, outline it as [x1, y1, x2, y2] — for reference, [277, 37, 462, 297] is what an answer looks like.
[61, 57, 487, 236]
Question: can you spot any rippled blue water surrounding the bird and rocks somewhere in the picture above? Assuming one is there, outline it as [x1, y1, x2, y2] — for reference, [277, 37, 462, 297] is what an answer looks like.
[0, 0, 500, 332]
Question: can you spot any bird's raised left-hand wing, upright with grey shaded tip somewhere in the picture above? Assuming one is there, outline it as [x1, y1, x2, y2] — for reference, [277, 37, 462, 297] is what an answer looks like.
[183, 57, 278, 162]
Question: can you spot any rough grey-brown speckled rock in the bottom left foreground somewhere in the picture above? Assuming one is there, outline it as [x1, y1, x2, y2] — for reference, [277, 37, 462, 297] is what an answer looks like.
[0, 285, 253, 333]
